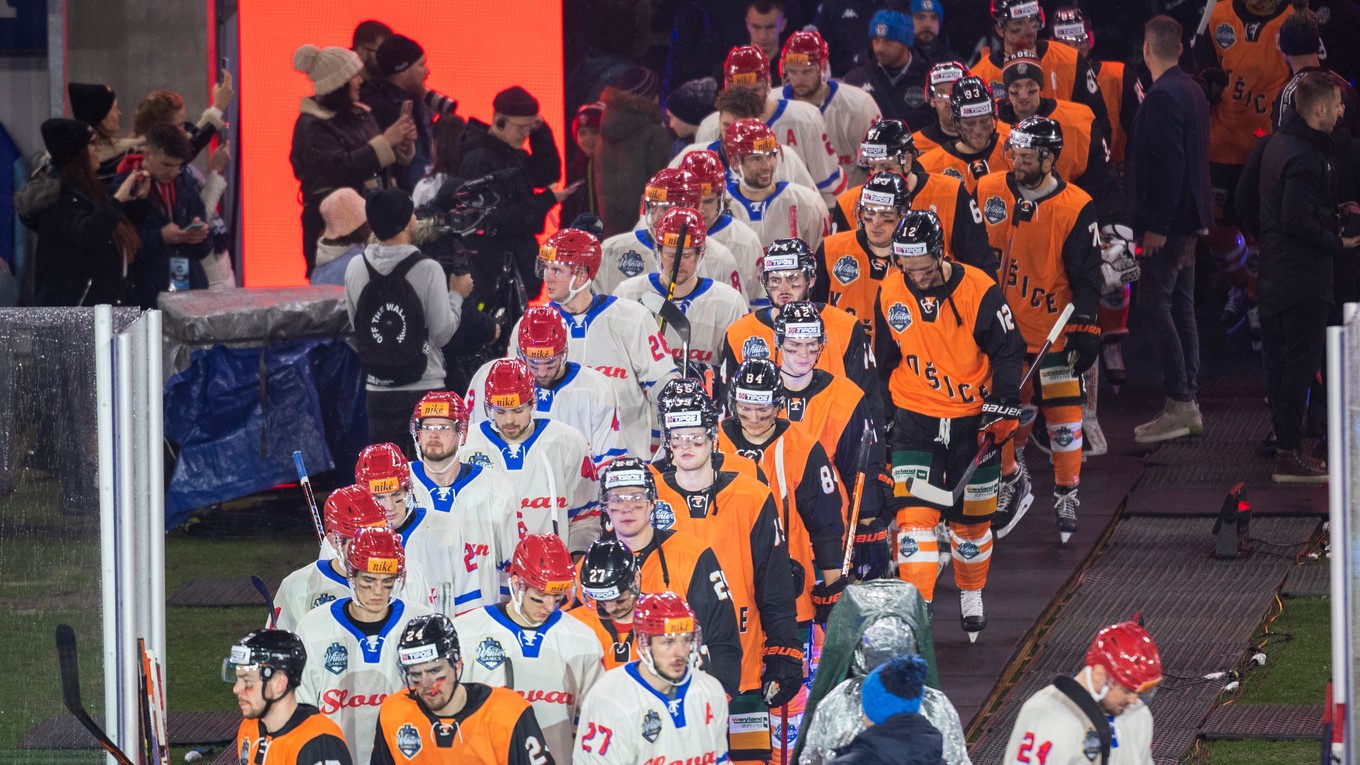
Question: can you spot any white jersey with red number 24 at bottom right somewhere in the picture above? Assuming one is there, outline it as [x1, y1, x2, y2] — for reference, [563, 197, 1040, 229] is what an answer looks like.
[1001, 685, 1152, 765]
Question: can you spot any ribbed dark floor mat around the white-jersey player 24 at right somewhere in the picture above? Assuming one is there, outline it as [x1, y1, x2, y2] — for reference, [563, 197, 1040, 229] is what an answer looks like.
[968, 517, 1316, 764]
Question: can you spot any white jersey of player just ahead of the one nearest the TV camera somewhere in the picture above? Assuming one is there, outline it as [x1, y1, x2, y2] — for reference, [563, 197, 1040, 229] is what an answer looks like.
[462, 361, 623, 468]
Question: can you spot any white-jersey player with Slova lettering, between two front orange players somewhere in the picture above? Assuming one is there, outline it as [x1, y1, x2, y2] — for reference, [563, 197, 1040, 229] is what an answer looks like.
[296, 527, 430, 762]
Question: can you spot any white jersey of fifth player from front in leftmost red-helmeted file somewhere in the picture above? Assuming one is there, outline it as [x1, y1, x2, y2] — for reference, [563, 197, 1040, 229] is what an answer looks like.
[458, 418, 601, 554]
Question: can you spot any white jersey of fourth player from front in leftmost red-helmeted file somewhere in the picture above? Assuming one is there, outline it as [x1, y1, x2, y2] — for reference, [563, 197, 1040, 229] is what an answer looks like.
[411, 461, 520, 607]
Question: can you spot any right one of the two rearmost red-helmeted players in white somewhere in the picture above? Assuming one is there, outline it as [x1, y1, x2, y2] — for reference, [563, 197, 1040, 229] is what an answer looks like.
[777, 31, 879, 186]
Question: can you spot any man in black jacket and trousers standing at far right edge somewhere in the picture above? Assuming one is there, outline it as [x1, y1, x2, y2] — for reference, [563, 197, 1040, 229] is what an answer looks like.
[1259, 72, 1360, 483]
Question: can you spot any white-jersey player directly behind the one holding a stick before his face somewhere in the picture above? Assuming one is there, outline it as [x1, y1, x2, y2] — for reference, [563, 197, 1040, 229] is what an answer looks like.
[594, 167, 759, 299]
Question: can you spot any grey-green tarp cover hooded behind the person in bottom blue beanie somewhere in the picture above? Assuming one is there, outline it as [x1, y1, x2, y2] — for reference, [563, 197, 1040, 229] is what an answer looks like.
[793, 580, 940, 761]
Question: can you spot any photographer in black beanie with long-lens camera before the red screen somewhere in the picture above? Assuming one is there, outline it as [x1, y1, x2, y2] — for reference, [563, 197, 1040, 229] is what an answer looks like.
[359, 34, 434, 193]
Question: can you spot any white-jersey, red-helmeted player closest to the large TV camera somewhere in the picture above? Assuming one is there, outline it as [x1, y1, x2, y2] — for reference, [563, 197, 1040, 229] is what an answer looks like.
[510, 229, 677, 457]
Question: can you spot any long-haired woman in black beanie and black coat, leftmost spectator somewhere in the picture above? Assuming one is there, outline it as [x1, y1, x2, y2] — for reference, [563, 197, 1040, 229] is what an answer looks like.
[23, 120, 151, 306]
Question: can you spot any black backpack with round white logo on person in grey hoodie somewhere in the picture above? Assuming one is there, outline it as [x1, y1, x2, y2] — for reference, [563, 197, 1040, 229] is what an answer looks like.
[354, 252, 430, 387]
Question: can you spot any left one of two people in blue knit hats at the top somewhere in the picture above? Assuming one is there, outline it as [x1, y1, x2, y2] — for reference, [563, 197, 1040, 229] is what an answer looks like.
[845, 10, 932, 131]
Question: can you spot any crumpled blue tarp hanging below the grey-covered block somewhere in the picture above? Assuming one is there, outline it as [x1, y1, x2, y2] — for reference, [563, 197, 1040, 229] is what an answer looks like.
[165, 340, 369, 530]
